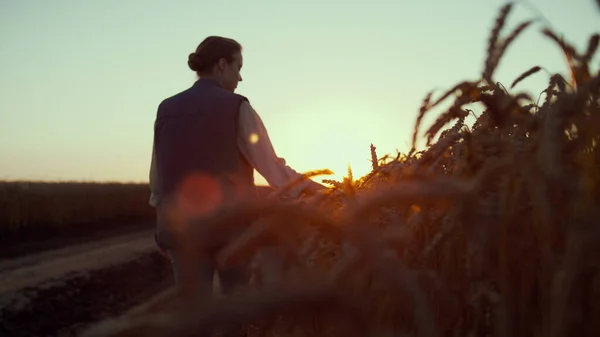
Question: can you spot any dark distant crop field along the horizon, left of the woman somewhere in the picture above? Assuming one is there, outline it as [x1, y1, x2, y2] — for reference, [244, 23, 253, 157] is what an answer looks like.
[0, 181, 154, 241]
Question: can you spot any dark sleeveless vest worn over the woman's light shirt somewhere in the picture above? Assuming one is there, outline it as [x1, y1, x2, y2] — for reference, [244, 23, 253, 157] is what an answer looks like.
[154, 79, 256, 210]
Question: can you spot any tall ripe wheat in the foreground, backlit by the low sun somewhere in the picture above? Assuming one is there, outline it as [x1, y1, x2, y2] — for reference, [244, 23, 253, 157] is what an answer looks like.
[79, 3, 600, 337]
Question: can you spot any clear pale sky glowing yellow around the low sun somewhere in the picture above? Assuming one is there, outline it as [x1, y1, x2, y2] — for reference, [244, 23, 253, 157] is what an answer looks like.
[0, 0, 600, 183]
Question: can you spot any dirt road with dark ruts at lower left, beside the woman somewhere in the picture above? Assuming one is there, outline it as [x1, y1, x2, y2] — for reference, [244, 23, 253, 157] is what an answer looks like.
[0, 230, 172, 337]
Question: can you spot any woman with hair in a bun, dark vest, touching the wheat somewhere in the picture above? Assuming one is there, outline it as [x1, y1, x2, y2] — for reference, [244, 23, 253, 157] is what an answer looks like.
[150, 36, 325, 293]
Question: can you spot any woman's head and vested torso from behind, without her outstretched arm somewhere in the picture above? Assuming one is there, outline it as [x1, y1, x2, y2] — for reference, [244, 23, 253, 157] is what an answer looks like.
[150, 36, 255, 250]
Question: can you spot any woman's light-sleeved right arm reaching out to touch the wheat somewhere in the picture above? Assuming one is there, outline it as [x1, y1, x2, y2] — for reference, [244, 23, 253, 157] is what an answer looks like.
[238, 101, 326, 196]
